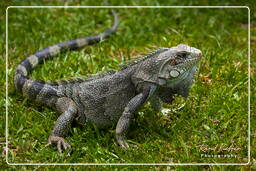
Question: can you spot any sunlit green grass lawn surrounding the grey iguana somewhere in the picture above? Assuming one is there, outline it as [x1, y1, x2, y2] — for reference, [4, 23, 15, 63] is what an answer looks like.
[0, 1, 256, 170]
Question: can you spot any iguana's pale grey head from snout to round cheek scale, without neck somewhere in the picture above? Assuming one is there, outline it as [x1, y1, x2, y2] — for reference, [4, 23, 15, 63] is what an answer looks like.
[157, 44, 202, 87]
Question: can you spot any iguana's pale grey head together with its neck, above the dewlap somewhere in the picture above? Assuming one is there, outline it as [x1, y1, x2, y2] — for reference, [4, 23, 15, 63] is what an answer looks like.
[132, 44, 202, 87]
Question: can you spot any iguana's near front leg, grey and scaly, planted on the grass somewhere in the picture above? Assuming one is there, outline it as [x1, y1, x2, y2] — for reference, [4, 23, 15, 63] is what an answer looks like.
[116, 86, 155, 148]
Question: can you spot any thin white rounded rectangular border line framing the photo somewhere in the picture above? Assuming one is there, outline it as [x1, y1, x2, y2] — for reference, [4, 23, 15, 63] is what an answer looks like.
[5, 6, 251, 165]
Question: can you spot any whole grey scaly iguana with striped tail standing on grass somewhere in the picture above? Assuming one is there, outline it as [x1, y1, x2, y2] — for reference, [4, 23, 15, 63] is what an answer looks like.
[14, 13, 202, 152]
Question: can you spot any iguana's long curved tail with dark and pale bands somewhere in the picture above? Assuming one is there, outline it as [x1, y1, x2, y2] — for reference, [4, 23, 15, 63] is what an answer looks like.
[14, 10, 119, 101]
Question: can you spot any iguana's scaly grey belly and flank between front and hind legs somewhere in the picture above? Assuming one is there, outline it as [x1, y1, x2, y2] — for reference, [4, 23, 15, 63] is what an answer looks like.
[76, 72, 136, 128]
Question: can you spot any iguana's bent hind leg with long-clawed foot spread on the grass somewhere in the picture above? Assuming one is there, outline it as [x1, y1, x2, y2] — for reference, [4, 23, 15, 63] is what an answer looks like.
[47, 97, 77, 152]
